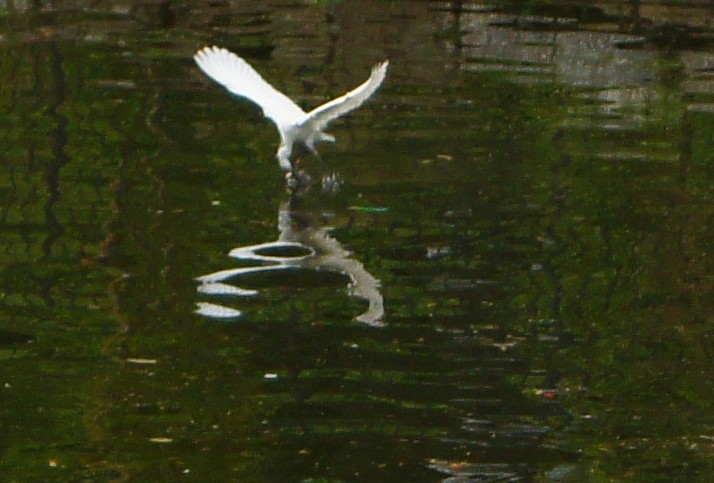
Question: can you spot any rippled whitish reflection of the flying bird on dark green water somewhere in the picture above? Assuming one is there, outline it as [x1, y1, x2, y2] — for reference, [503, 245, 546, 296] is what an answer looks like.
[196, 187, 384, 326]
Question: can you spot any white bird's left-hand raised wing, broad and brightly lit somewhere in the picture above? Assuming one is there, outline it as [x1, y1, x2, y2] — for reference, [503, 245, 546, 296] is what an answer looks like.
[193, 46, 306, 126]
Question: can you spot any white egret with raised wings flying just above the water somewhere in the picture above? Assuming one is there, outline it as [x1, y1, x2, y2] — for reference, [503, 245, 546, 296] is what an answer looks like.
[193, 46, 389, 173]
